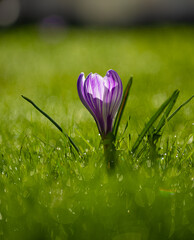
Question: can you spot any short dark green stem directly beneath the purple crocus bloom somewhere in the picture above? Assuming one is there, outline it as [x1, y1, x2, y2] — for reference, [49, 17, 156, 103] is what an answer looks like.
[103, 133, 117, 169]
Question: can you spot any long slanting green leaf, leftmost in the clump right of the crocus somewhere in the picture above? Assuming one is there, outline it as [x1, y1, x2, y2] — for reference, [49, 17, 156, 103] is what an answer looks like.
[131, 90, 178, 153]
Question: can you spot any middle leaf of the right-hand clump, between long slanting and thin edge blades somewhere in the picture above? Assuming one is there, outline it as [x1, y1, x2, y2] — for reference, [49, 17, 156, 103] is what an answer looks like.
[154, 90, 179, 135]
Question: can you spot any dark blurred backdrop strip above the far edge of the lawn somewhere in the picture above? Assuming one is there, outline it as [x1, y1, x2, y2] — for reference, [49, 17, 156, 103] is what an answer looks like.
[0, 0, 194, 26]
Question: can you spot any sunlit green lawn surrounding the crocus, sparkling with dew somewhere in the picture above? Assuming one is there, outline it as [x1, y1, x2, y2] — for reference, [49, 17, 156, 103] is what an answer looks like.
[0, 26, 194, 240]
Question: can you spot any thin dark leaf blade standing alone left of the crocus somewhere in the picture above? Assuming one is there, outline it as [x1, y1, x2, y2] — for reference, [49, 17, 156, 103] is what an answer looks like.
[22, 95, 81, 155]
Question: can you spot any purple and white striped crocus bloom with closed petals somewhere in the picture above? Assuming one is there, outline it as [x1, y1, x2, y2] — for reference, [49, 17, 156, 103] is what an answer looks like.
[77, 70, 123, 139]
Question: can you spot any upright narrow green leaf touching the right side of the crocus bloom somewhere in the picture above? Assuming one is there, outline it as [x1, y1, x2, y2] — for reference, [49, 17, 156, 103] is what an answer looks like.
[113, 77, 133, 138]
